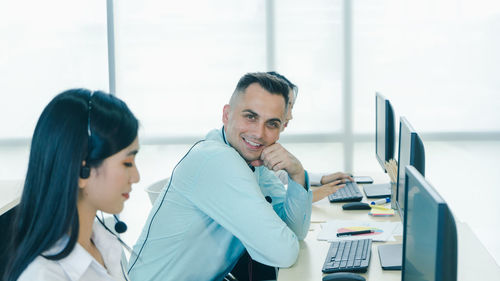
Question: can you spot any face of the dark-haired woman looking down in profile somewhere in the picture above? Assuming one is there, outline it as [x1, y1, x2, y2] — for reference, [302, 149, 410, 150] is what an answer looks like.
[79, 138, 140, 214]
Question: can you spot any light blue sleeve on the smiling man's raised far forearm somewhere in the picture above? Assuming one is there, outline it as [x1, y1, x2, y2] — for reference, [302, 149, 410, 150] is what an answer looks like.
[259, 167, 312, 240]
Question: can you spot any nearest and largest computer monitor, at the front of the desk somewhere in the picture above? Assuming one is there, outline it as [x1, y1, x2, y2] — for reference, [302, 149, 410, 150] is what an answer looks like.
[402, 166, 457, 281]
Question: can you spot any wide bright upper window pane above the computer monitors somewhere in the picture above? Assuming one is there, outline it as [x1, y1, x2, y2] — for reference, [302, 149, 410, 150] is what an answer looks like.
[353, 0, 500, 132]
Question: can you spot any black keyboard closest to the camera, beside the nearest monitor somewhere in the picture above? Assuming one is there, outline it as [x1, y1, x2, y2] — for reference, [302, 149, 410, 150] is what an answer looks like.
[323, 239, 372, 273]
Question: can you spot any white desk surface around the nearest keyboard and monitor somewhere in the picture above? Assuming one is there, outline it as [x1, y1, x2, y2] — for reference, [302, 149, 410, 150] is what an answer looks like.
[278, 184, 500, 281]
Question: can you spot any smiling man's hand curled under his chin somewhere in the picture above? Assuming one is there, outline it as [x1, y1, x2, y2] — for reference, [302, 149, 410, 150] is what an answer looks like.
[250, 143, 306, 187]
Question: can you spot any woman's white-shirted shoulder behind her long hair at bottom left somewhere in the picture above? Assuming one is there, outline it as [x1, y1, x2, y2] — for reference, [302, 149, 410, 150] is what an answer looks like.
[17, 256, 68, 281]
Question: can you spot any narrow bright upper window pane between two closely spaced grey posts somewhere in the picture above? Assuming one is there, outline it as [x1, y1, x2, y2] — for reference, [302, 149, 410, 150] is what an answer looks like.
[274, 0, 343, 134]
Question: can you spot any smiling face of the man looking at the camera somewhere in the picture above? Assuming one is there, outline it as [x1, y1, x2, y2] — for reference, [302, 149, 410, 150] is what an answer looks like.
[222, 83, 285, 163]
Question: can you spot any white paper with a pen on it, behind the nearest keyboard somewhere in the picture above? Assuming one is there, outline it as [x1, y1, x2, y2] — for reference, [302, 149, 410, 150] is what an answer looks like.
[317, 220, 400, 241]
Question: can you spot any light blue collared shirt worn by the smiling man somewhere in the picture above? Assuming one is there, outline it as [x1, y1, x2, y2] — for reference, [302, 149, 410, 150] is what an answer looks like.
[129, 130, 312, 280]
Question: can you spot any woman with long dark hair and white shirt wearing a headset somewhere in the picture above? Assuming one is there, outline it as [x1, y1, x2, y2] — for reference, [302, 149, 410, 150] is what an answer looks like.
[2, 89, 139, 281]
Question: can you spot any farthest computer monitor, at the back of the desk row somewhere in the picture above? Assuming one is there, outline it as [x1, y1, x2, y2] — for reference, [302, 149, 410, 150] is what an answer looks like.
[375, 93, 396, 171]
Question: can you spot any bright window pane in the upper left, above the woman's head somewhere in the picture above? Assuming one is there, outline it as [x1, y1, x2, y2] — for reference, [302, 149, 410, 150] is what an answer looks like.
[0, 0, 108, 138]
